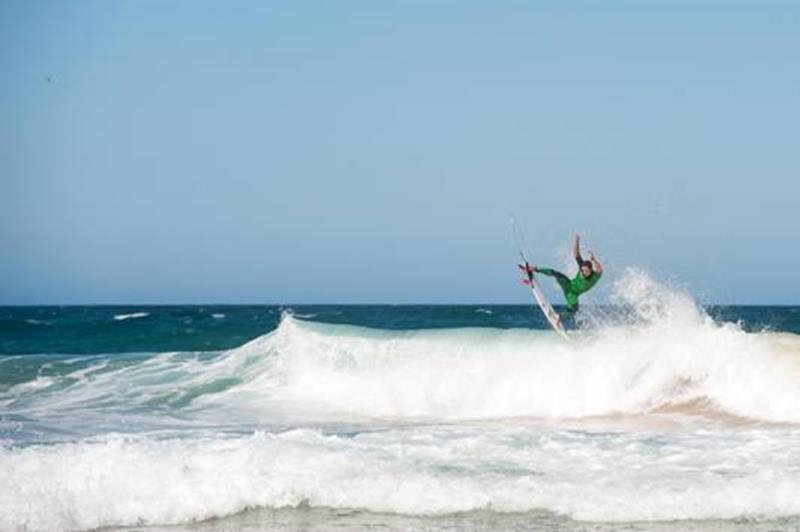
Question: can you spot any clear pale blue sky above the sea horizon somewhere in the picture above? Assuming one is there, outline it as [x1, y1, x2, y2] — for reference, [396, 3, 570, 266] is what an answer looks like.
[0, 0, 800, 304]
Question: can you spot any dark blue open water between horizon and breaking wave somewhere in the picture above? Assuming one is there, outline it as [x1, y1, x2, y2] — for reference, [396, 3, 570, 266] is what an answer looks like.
[0, 305, 800, 355]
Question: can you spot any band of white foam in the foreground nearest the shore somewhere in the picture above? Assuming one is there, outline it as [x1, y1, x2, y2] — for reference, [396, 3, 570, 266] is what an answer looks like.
[0, 427, 800, 530]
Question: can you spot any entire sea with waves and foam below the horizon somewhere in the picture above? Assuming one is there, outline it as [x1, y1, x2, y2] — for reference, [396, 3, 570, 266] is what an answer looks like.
[0, 271, 800, 531]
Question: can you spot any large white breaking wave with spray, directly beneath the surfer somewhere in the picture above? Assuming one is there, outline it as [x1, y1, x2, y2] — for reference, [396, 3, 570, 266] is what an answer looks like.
[6, 271, 800, 423]
